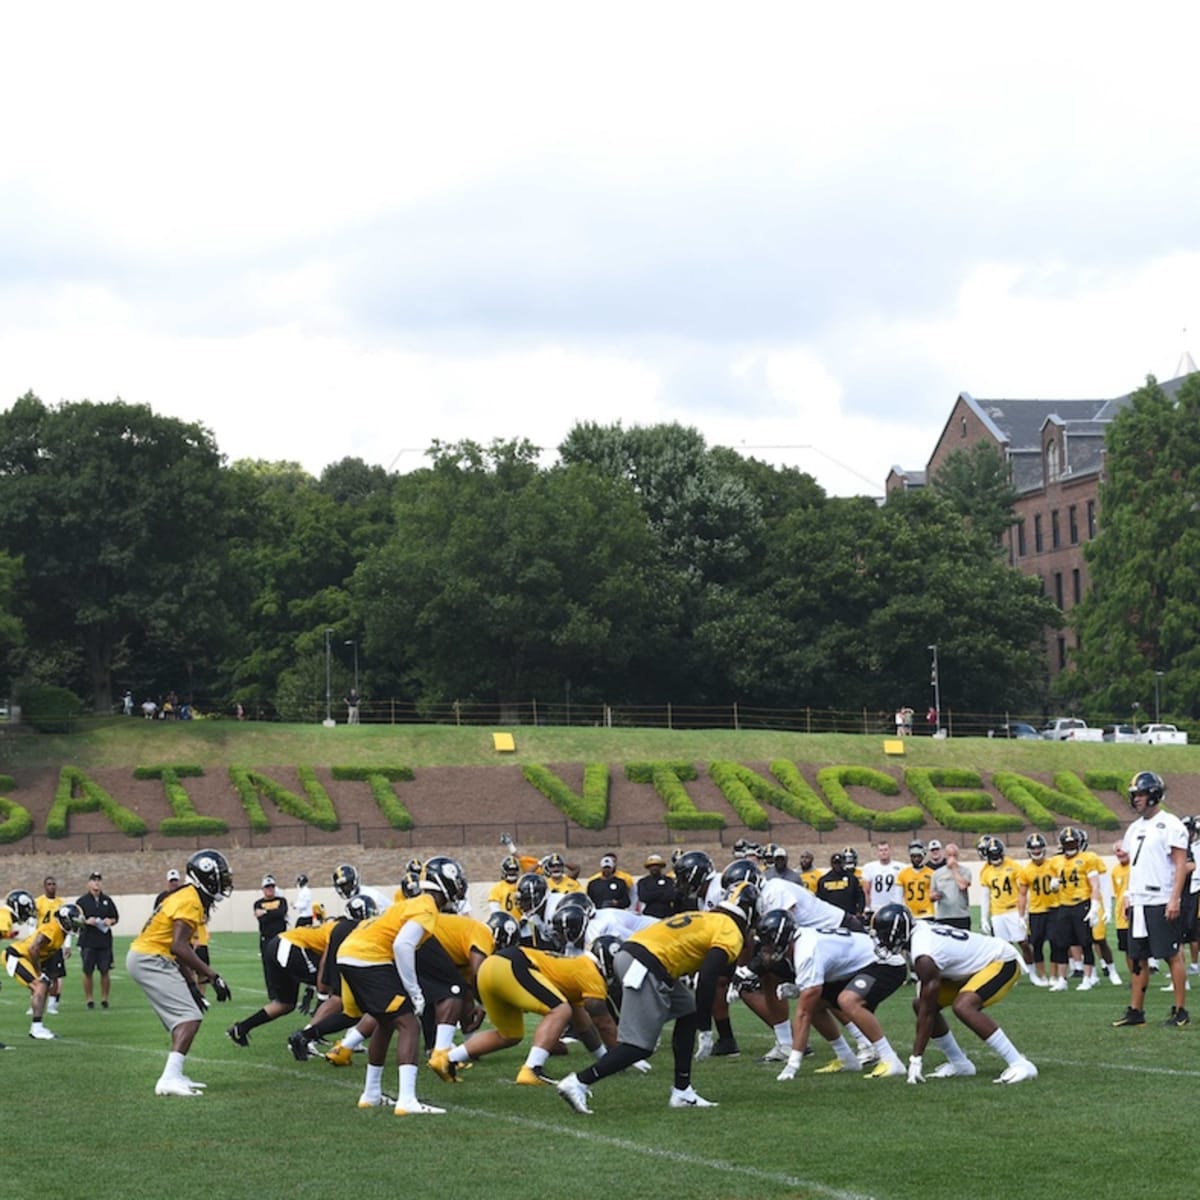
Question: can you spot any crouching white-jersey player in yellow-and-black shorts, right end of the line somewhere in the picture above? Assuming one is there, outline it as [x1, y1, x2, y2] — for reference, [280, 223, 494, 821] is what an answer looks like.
[871, 904, 1038, 1084]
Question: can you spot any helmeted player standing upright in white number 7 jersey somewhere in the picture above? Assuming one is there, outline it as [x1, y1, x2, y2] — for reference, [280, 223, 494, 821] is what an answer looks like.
[1112, 770, 1189, 1028]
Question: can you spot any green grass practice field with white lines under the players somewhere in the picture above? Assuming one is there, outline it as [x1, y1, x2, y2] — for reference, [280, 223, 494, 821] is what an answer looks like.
[14, 934, 1200, 1200]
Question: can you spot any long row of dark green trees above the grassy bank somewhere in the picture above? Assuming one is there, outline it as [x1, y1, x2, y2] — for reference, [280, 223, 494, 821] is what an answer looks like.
[0, 382, 1200, 719]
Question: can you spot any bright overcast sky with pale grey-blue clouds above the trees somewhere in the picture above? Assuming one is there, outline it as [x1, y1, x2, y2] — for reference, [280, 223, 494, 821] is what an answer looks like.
[0, 0, 1200, 496]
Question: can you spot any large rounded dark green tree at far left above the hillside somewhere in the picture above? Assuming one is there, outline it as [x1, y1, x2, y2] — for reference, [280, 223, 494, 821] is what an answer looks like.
[0, 392, 224, 712]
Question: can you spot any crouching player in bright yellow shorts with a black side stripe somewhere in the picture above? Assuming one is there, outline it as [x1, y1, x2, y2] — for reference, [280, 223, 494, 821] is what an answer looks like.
[446, 905, 617, 1086]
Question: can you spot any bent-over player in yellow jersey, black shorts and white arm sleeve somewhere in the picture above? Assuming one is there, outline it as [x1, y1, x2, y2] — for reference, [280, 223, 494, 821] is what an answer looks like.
[337, 856, 467, 1116]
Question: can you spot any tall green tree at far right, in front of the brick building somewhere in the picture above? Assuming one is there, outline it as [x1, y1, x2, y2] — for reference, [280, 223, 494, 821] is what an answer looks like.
[1062, 374, 1200, 716]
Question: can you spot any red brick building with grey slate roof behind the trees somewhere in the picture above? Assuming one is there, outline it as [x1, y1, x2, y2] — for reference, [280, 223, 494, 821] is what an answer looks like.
[887, 361, 1192, 678]
